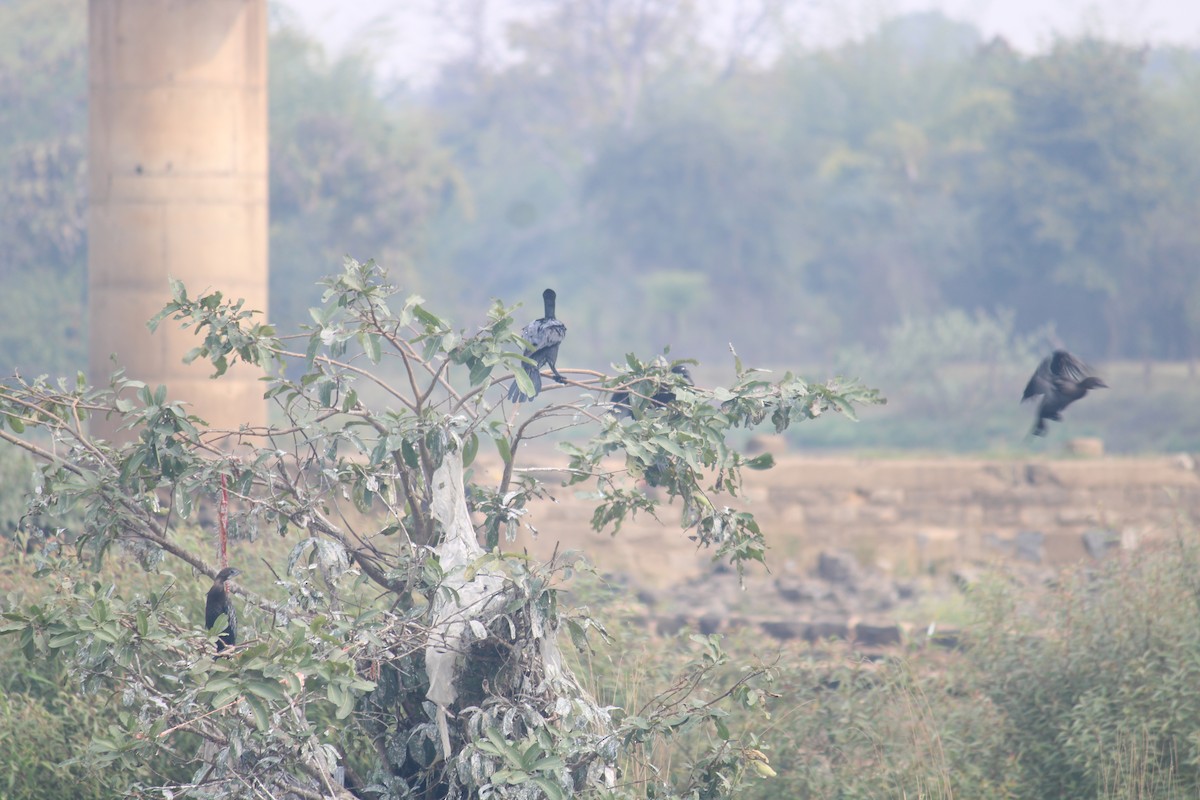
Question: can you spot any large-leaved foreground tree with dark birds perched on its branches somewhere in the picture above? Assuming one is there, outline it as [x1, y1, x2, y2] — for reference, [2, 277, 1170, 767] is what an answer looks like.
[0, 258, 882, 800]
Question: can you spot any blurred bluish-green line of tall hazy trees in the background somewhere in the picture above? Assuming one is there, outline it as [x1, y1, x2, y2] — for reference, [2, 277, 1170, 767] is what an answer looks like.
[0, 0, 1200, 450]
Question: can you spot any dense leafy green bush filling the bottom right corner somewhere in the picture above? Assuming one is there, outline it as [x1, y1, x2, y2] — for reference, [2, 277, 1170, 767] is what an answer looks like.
[968, 535, 1200, 798]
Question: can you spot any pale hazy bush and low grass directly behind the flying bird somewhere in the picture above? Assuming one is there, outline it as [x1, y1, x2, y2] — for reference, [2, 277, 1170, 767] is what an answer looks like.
[788, 311, 1200, 458]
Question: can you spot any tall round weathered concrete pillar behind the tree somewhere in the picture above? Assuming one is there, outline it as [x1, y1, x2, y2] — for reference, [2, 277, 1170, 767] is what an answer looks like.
[88, 0, 268, 435]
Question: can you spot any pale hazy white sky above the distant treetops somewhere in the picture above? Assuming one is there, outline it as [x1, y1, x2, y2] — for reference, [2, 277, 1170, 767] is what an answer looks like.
[272, 0, 1200, 82]
